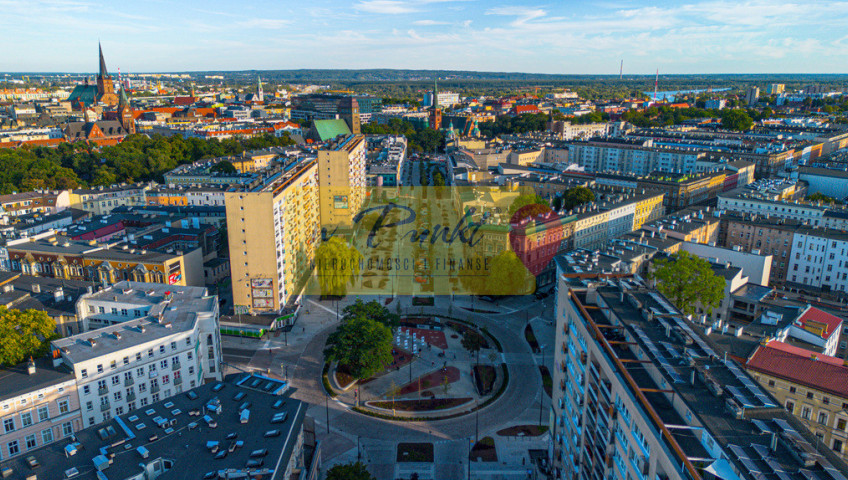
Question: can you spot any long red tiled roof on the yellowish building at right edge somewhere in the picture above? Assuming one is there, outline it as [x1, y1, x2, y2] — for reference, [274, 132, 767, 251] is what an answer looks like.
[746, 340, 848, 397]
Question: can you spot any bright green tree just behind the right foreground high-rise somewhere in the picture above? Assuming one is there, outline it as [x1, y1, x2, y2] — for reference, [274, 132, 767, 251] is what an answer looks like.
[649, 251, 725, 315]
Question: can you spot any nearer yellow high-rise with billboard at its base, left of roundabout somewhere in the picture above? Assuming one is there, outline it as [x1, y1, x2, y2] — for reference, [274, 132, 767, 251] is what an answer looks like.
[224, 158, 320, 313]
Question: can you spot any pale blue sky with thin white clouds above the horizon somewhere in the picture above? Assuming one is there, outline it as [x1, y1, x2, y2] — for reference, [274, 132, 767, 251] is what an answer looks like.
[0, 0, 848, 74]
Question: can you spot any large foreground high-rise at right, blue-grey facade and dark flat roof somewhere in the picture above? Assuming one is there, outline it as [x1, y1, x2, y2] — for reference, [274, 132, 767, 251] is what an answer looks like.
[550, 274, 848, 480]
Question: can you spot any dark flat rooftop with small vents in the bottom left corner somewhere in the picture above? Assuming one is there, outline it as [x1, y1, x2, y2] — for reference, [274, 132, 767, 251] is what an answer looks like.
[0, 374, 306, 480]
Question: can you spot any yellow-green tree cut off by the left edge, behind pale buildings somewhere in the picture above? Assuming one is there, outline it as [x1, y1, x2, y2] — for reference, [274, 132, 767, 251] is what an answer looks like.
[0, 307, 58, 365]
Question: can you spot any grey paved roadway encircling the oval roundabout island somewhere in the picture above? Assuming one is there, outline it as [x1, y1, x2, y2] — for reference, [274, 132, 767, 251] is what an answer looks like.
[224, 290, 554, 478]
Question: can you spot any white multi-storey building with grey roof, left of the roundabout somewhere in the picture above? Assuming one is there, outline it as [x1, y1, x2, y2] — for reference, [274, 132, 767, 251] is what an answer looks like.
[51, 281, 222, 427]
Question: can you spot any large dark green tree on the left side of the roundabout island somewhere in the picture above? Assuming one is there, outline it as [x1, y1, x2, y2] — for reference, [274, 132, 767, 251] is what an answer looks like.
[324, 315, 392, 379]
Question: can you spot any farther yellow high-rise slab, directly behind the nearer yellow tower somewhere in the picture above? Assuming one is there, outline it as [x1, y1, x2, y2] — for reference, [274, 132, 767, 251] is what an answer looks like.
[318, 135, 367, 230]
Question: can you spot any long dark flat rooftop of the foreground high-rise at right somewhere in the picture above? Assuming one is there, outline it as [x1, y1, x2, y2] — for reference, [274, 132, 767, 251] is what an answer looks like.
[573, 277, 848, 480]
